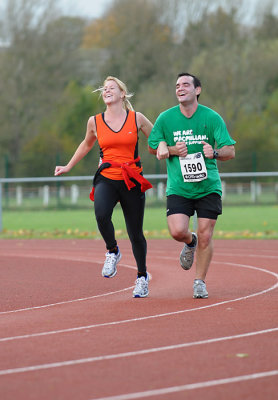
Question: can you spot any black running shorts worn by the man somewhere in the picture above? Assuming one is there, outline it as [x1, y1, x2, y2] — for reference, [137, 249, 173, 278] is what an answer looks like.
[167, 193, 222, 219]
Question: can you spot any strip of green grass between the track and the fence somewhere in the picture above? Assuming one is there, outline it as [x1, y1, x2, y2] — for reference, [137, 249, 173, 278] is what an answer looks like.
[0, 206, 278, 239]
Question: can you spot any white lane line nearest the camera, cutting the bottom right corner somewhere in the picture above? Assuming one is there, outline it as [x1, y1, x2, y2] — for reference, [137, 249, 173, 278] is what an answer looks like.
[91, 370, 278, 400]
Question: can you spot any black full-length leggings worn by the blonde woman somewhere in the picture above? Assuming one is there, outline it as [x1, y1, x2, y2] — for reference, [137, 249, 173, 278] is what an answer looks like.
[94, 175, 147, 274]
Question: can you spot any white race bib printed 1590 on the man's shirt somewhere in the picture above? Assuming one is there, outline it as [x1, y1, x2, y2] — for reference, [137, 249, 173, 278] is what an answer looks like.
[179, 152, 208, 182]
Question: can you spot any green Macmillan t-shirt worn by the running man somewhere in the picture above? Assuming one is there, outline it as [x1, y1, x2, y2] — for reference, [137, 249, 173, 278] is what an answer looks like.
[148, 104, 236, 199]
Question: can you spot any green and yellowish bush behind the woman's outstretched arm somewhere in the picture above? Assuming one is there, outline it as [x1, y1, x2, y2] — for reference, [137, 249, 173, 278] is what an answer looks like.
[18, 81, 102, 176]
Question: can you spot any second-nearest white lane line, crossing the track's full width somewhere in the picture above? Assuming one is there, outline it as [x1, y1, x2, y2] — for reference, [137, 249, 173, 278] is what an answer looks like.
[0, 327, 278, 376]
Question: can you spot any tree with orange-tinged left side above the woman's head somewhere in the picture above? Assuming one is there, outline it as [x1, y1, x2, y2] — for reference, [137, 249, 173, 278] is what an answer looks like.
[83, 0, 172, 91]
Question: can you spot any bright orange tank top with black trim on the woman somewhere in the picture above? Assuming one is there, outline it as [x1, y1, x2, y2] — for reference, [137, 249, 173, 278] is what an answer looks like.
[95, 110, 142, 180]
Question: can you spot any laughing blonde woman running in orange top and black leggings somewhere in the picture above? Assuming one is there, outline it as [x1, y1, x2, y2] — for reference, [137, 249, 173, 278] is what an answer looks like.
[55, 76, 152, 297]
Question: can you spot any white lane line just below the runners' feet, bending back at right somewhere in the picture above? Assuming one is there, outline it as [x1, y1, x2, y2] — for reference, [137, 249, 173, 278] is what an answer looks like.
[0, 262, 278, 342]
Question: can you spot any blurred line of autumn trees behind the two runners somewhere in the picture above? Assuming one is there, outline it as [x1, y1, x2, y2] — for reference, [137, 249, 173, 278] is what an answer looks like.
[0, 0, 278, 176]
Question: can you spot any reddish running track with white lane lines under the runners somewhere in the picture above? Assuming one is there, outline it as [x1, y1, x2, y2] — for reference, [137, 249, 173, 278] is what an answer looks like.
[0, 239, 278, 400]
